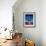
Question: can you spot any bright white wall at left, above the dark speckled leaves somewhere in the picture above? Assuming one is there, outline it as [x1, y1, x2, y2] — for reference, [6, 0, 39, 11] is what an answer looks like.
[0, 0, 16, 29]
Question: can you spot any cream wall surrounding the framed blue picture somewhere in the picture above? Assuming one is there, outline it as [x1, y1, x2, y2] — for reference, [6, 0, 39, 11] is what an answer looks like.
[13, 0, 41, 46]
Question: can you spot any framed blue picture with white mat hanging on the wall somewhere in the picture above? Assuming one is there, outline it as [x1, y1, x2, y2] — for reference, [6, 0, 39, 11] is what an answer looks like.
[23, 12, 36, 27]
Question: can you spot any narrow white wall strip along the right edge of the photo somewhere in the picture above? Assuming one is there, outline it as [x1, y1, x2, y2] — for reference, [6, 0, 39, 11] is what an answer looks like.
[40, 0, 46, 46]
